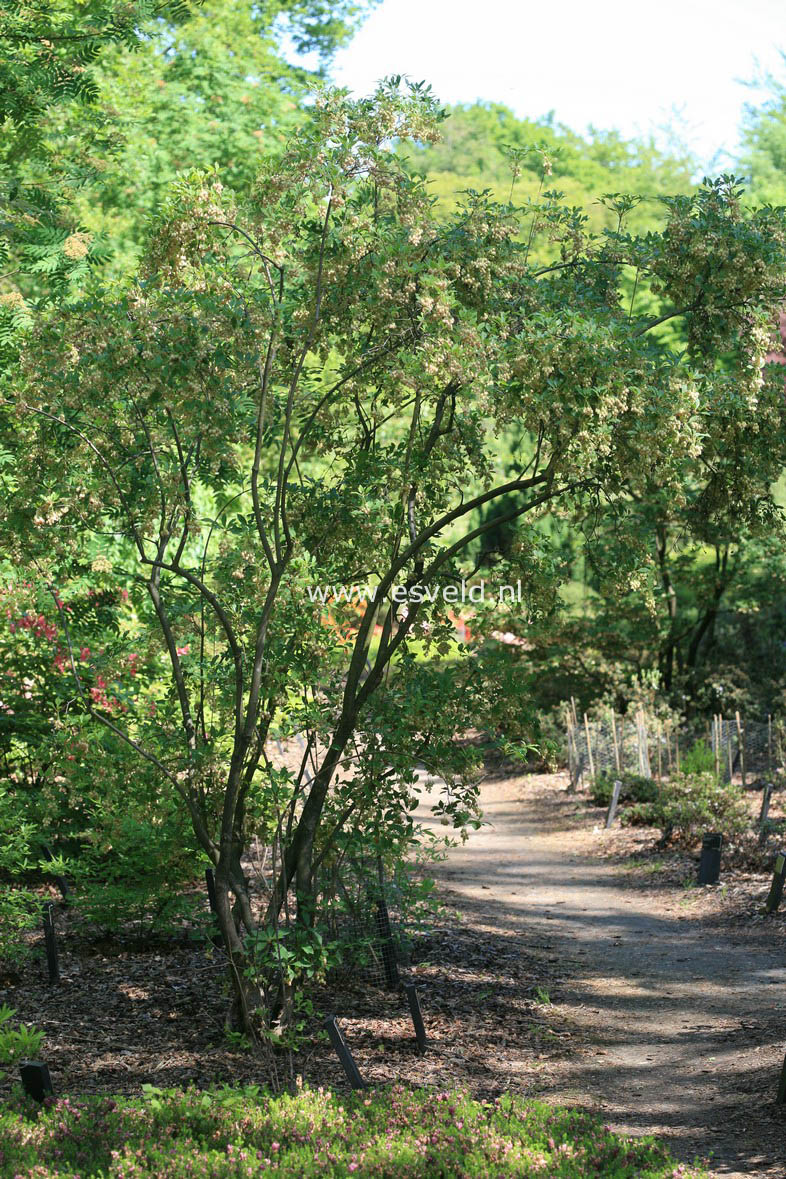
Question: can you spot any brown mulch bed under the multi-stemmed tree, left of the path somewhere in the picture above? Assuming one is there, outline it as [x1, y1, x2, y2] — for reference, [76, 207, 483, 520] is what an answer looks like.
[0, 891, 569, 1098]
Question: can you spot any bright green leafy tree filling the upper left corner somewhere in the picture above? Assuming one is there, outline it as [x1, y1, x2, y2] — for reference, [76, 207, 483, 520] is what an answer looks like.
[0, 0, 377, 344]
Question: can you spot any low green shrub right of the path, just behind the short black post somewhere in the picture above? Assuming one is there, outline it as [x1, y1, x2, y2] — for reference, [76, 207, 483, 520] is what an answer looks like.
[622, 773, 751, 844]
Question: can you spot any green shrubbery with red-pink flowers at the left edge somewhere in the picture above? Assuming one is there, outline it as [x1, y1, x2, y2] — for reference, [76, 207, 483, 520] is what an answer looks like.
[0, 580, 198, 938]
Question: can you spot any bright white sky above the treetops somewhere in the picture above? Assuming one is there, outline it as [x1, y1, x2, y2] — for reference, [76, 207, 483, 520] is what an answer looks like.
[332, 0, 786, 170]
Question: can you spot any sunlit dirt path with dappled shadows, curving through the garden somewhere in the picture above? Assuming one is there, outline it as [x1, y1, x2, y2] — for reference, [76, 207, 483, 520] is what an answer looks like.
[421, 776, 786, 1179]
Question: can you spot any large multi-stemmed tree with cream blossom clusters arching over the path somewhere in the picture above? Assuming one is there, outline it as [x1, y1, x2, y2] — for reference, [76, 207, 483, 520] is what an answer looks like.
[2, 79, 786, 1034]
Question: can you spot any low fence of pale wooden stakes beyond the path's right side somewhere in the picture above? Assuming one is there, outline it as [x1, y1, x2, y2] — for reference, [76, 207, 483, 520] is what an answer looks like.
[566, 699, 786, 788]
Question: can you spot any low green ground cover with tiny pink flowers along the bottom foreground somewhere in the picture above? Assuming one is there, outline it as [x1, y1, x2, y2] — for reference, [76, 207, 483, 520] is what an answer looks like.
[0, 1086, 705, 1179]
